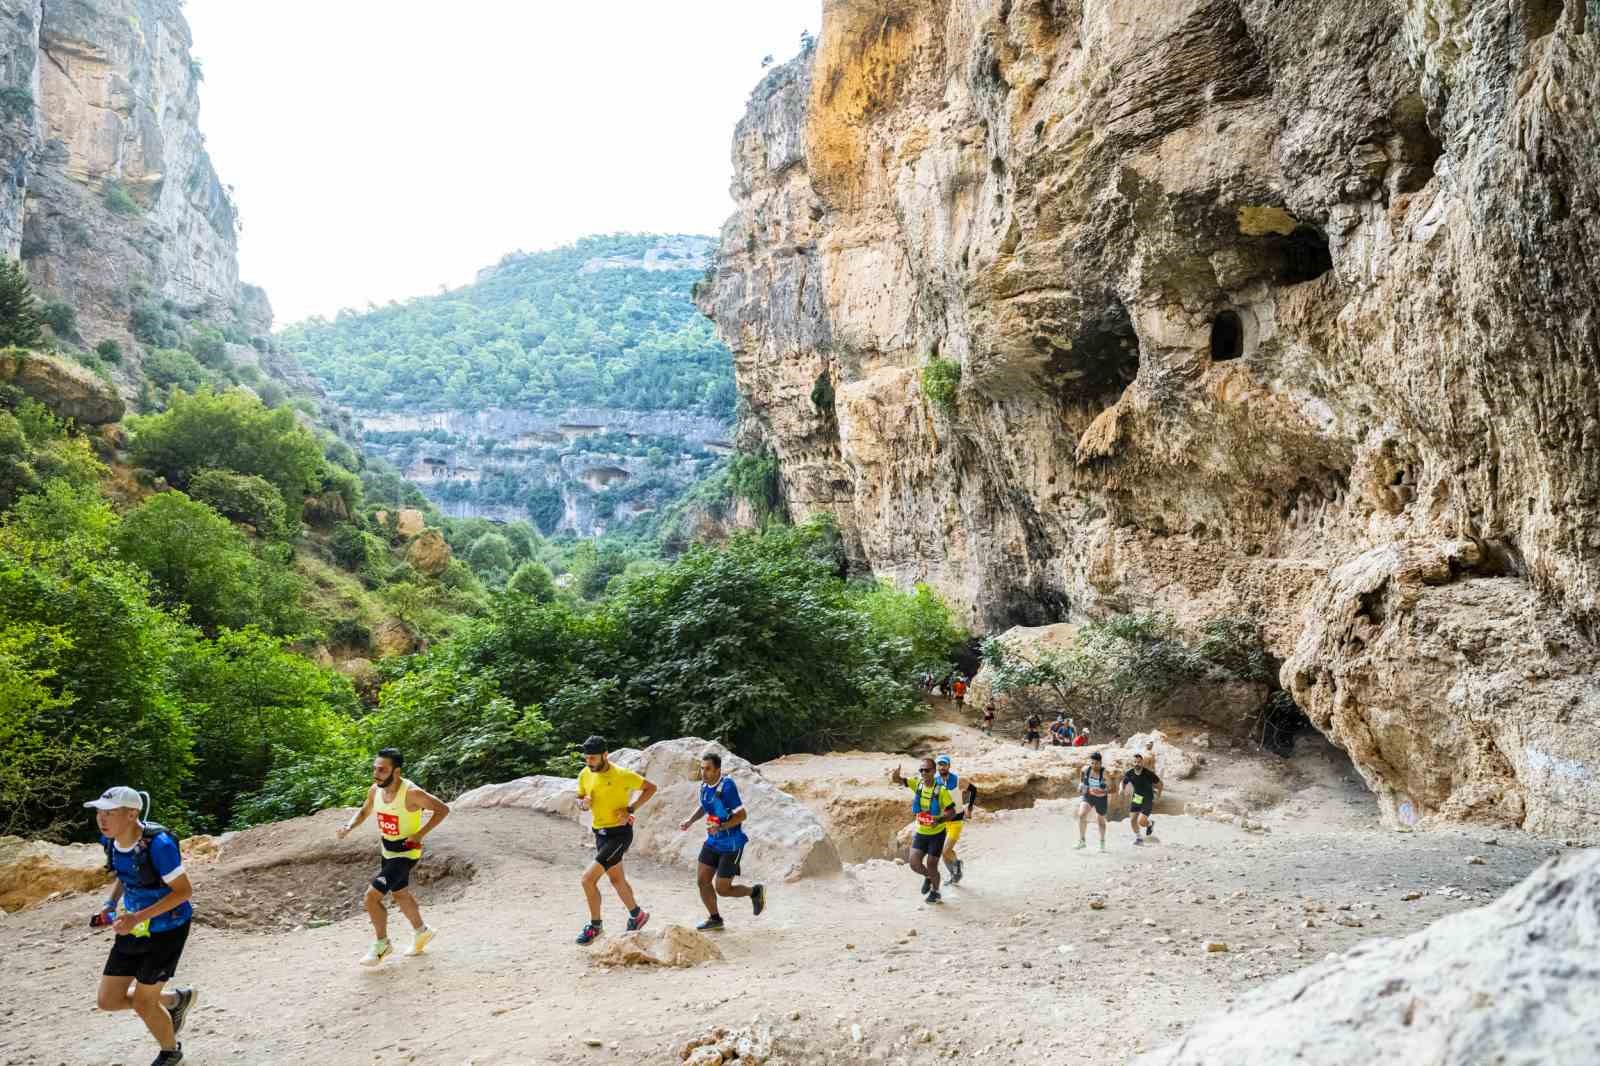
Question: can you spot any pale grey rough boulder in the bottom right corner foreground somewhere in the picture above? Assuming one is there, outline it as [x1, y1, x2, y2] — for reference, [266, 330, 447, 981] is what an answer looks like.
[1134, 850, 1600, 1066]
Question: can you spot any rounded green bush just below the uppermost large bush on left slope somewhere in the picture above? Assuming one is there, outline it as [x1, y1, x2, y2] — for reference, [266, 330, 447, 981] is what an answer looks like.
[115, 491, 306, 634]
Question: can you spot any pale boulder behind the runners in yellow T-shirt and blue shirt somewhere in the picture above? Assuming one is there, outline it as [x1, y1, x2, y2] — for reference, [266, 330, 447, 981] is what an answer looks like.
[454, 736, 838, 880]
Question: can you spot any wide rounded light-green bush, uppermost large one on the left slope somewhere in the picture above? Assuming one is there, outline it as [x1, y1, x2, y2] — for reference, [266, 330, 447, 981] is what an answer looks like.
[130, 389, 326, 527]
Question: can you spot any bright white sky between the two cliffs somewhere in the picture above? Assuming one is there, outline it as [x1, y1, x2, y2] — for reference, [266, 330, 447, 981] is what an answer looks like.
[184, 0, 822, 327]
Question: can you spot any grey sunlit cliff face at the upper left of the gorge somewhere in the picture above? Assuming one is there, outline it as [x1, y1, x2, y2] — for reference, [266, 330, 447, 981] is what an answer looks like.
[0, 0, 246, 343]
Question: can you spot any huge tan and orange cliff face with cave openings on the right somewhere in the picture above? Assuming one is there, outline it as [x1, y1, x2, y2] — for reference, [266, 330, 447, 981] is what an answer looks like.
[699, 0, 1600, 840]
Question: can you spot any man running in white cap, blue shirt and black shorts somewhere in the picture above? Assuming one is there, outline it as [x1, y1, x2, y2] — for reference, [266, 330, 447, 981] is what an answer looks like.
[85, 786, 197, 1066]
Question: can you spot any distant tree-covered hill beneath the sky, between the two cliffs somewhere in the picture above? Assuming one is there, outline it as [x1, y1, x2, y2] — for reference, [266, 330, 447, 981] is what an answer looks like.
[283, 234, 734, 418]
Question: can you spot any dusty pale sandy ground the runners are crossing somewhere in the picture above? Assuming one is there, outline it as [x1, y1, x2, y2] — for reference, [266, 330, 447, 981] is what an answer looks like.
[0, 738, 1552, 1066]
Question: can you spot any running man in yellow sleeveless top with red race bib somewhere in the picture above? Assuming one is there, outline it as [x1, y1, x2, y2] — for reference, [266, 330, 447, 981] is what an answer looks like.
[334, 747, 450, 967]
